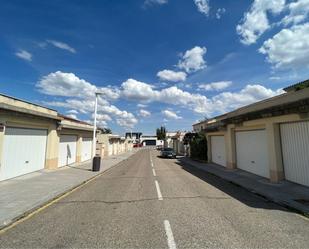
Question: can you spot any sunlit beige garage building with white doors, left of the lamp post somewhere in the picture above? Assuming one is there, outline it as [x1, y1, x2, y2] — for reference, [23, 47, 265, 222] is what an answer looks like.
[0, 95, 93, 181]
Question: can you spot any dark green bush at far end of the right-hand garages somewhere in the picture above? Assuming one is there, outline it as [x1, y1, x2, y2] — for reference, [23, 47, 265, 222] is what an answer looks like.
[190, 133, 207, 160]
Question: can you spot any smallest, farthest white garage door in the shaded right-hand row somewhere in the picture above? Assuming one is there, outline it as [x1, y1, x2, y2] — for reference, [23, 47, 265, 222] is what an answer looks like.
[210, 136, 226, 167]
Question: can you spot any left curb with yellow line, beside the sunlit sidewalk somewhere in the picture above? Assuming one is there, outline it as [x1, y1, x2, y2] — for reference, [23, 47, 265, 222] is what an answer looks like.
[0, 151, 138, 235]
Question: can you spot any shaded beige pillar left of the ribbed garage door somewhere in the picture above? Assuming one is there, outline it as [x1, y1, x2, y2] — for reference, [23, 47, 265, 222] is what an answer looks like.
[266, 122, 284, 183]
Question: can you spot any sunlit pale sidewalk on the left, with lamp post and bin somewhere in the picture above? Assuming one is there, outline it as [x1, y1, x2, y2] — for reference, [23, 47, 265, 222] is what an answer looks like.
[0, 149, 138, 229]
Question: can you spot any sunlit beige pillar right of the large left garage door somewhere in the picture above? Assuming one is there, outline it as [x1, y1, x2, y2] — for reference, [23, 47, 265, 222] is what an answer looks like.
[45, 124, 60, 169]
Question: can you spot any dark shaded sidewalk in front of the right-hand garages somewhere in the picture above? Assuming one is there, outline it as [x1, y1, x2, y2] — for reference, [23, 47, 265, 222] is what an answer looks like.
[179, 157, 309, 216]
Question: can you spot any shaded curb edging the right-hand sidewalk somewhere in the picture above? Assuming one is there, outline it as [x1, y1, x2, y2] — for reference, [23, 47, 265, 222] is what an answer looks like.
[183, 161, 309, 218]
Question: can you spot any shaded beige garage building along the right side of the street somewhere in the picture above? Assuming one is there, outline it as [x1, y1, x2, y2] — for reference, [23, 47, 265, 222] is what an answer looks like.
[193, 81, 309, 186]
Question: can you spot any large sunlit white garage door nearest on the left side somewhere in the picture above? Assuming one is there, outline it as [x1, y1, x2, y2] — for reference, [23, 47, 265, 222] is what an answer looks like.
[0, 127, 47, 180]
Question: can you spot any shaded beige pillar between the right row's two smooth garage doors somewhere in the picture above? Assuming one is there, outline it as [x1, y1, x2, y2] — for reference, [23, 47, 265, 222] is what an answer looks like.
[225, 124, 236, 169]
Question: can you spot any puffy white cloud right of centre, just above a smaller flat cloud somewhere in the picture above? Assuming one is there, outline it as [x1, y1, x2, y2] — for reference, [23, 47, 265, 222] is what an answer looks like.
[178, 46, 207, 73]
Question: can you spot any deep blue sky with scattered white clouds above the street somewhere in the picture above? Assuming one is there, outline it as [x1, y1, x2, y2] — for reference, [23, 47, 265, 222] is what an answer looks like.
[0, 0, 309, 134]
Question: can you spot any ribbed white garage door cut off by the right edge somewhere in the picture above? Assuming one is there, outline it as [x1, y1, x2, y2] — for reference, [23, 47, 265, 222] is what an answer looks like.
[280, 121, 309, 186]
